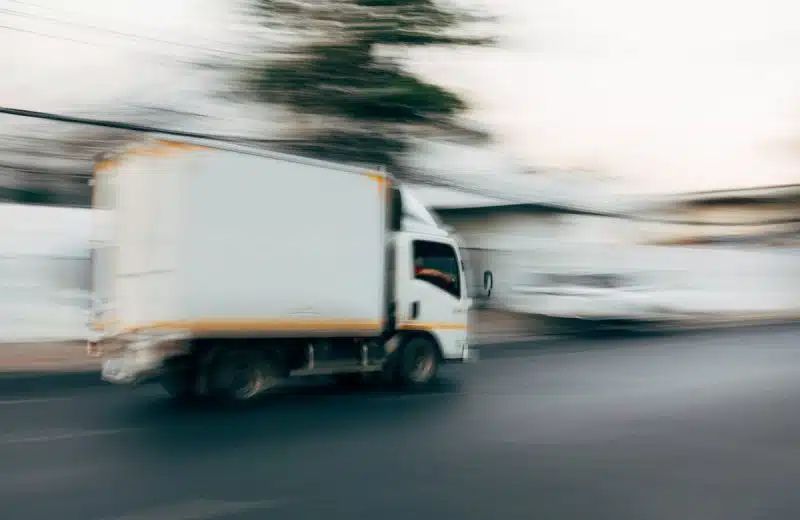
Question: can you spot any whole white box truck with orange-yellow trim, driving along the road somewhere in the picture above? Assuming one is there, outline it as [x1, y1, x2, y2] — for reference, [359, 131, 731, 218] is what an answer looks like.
[89, 138, 474, 400]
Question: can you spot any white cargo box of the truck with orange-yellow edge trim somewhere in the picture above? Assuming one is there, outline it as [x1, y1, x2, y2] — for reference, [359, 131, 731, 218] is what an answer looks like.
[95, 140, 390, 336]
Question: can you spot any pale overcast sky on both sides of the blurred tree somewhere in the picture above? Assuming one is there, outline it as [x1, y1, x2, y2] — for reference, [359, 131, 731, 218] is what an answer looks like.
[0, 0, 800, 192]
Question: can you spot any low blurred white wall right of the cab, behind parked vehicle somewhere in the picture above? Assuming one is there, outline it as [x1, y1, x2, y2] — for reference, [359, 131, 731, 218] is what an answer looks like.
[510, 245, 800, 314]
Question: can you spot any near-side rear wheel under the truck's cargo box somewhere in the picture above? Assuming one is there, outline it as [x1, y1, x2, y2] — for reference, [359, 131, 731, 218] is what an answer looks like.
[209, 350, 281, 403]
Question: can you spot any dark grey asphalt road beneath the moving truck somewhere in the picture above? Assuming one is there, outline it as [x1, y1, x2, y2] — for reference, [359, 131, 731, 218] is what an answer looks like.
[0, 327, 800, 520]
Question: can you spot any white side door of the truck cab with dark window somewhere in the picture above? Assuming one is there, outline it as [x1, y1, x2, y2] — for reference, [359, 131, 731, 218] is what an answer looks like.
[395, 235, 470, 359]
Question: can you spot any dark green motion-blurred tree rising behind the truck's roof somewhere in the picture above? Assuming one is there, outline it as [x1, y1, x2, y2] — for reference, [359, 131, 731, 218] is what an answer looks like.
[230, 0, 492, 174]
